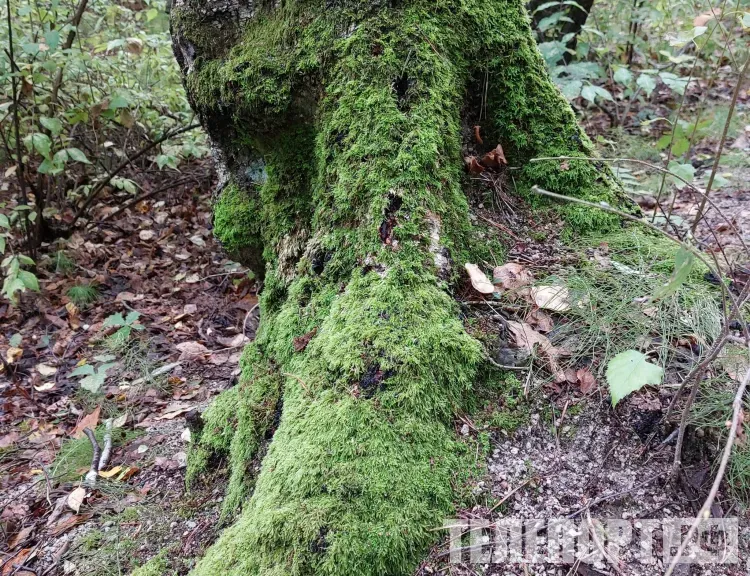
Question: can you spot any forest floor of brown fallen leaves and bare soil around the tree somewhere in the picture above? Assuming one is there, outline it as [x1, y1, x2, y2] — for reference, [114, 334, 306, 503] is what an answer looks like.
[0, 93, 750, 576]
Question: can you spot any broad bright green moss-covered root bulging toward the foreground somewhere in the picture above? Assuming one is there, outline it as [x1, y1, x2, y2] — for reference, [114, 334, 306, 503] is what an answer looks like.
[188, 272, 481, 576]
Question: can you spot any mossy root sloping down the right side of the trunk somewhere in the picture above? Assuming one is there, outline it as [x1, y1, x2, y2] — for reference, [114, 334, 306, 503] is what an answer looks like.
[476, 2, 631, 233]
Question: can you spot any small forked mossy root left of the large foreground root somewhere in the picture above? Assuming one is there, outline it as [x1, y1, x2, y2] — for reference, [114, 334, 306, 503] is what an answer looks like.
[185, 345, 282, 518]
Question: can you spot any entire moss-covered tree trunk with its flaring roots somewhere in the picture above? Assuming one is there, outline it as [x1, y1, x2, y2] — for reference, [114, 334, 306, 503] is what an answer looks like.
[171, 0, 619, 576]
